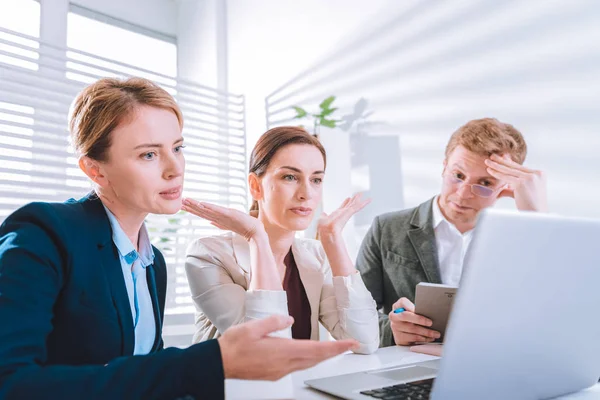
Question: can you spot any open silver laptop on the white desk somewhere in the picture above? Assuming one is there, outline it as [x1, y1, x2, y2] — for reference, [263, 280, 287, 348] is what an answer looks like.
[305, 210, 600, 400]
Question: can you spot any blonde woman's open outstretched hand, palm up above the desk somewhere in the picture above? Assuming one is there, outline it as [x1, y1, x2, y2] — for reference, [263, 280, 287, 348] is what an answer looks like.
[218, 315, 358, 380]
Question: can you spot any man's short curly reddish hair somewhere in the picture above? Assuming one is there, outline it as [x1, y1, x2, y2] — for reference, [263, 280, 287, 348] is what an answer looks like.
[446, 118, 527, 164]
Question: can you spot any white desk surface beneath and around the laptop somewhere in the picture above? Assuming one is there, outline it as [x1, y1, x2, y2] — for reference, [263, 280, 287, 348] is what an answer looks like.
[225, 346, 600, 400]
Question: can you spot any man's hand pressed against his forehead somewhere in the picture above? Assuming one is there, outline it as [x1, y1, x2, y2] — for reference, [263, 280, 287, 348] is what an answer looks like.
[485, 154, 548, 212]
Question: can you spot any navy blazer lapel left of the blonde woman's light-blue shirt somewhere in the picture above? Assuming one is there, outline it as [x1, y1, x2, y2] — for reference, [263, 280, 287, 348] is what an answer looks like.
[80, 193, 135, 356]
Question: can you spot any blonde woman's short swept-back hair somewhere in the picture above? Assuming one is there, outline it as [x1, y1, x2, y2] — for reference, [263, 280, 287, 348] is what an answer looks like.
[69, 78, 183, 161]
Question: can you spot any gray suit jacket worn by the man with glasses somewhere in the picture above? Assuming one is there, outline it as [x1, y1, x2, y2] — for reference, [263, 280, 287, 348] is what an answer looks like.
[356, 199, 441, 347]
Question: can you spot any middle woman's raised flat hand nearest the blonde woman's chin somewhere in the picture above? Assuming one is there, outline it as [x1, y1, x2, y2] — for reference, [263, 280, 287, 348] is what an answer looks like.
[181, 198, 264, 241]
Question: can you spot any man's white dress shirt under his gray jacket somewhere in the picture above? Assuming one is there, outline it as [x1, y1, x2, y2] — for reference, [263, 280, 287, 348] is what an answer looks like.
[433, 196, 473, 286]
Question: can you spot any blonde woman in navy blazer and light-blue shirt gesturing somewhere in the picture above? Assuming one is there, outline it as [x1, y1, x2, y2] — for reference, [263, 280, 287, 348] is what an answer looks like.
[0, 78, 356, 399]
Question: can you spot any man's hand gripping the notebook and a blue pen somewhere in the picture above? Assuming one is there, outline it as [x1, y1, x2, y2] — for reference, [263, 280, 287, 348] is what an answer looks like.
[389, 297, 440, 346]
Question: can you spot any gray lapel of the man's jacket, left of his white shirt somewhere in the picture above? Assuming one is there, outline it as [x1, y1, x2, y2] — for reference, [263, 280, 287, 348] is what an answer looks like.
[408, 199, 442, 283]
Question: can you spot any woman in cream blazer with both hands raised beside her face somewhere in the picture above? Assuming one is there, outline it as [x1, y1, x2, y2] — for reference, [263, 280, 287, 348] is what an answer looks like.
[183, 127, 379, 353]
